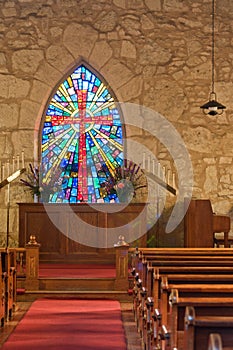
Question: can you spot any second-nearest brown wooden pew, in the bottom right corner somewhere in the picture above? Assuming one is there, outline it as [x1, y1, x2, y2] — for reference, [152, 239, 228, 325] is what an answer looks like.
[184, 306, 233, 350]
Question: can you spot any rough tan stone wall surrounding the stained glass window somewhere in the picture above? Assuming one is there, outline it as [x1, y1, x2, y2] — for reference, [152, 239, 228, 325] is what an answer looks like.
[0, 0, 233, 245]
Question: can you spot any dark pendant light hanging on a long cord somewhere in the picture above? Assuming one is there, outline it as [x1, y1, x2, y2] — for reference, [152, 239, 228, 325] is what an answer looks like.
[200, 0, 226, 116]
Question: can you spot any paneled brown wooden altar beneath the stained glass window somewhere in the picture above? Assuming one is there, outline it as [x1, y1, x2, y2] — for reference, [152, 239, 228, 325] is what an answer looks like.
[18, 203, 147, 264]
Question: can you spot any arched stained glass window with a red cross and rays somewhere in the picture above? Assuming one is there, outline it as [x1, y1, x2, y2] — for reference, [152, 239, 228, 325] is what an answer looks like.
[41, 64, 123, 203]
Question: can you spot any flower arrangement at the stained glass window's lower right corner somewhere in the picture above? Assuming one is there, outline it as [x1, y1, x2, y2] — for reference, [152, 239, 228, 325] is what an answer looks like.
[100, 159, 147, 202]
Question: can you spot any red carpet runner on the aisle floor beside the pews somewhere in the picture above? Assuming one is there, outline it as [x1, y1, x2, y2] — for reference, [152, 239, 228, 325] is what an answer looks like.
[2, 299, 127, 350]
